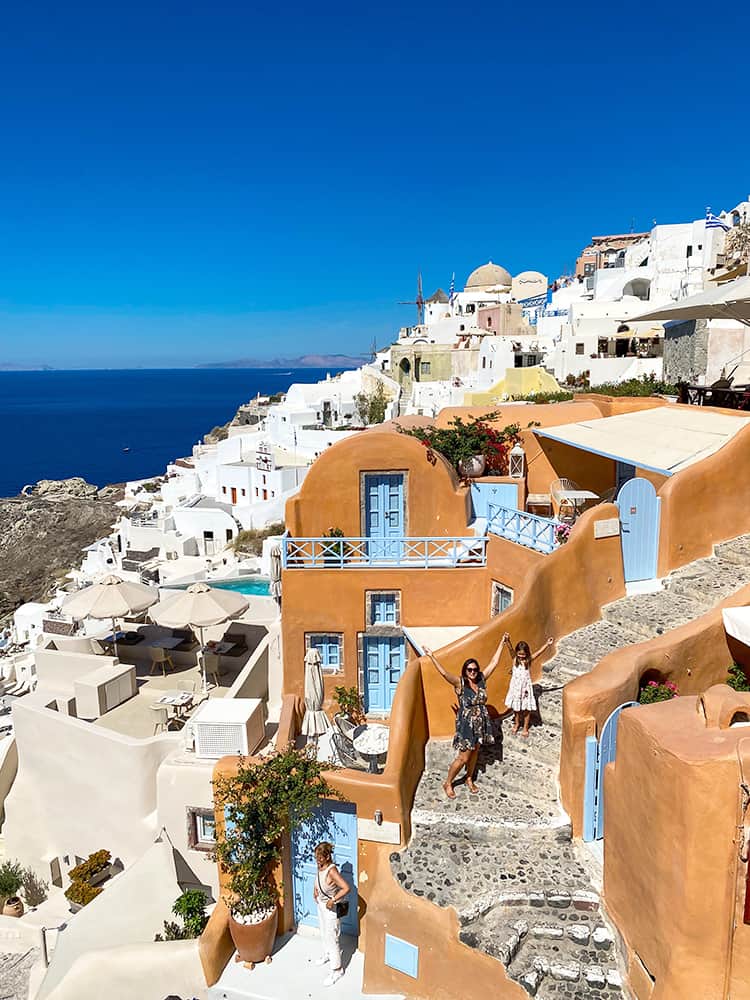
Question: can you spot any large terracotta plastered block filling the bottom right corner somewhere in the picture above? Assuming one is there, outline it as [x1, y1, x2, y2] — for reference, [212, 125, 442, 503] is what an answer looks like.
[604, 687, 750, 1000]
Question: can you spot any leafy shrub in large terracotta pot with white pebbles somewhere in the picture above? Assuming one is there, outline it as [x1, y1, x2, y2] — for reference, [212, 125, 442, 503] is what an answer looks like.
[213, 746, 337, 965]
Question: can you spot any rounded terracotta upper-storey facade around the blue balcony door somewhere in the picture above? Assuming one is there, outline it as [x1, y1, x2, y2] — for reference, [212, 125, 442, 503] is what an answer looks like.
[286, 430, 471, 538]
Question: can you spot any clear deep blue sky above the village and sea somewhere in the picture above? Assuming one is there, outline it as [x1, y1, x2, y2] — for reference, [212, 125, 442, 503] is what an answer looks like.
[0, 0, 750, 367]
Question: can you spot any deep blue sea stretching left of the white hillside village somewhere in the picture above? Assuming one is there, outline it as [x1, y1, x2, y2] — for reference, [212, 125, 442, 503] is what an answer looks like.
[0, 368, 346, 496]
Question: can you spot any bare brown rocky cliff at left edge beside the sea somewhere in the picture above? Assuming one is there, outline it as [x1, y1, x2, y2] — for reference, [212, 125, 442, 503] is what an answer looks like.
[0, 480, 122, 621]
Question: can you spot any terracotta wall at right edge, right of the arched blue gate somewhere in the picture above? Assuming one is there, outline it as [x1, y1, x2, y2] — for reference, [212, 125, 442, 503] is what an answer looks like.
[659, 424, 750, 576]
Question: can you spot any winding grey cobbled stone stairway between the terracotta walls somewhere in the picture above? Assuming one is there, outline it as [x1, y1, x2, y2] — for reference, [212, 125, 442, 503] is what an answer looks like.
[391, 536, 750, 1000]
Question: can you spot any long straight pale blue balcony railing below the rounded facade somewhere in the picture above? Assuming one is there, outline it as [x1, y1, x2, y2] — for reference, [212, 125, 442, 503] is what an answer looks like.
[281, 535, 487, 569]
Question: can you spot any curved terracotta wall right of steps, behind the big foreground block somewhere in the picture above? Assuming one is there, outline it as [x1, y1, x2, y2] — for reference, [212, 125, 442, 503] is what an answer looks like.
[560, 587, 750, 836]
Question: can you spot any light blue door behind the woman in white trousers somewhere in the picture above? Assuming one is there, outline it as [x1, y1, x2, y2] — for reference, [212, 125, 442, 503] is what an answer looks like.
[292, 801, 359, 936]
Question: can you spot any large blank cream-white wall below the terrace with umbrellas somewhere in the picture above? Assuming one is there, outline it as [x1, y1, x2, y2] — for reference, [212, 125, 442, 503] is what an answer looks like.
[3, 695, 180, 879]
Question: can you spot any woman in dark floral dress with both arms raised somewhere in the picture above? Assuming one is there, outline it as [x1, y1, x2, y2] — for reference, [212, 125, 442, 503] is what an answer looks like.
[425, 633, 508, 799]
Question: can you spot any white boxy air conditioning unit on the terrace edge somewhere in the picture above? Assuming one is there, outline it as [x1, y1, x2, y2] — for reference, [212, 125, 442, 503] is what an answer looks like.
[190, 698, 265, 760]
